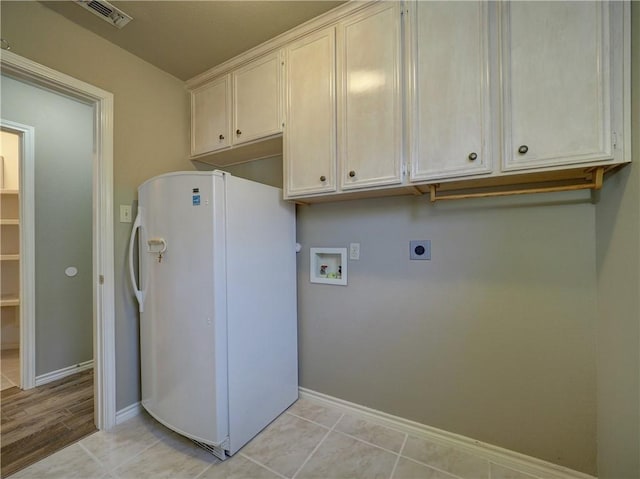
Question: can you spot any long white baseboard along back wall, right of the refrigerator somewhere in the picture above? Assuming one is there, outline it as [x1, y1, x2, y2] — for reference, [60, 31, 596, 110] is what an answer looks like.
[299, 387, 596, 479]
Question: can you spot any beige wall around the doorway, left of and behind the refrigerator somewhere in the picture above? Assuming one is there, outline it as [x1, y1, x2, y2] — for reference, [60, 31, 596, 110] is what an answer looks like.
[0, 1, 194, 409]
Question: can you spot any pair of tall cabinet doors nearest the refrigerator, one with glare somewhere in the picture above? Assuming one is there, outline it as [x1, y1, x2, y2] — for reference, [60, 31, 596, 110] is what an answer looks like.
[283, 2, 403, 197]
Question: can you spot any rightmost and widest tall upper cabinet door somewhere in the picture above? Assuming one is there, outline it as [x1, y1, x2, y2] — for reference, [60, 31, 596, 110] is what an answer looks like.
[502, 2, 612, 170]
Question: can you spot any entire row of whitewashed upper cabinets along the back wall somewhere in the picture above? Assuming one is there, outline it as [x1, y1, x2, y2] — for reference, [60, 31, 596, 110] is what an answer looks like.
[188, 0, 631, 201]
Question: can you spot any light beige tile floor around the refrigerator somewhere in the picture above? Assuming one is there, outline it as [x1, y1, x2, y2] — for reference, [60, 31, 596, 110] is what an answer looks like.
[10, 399, 534, 479]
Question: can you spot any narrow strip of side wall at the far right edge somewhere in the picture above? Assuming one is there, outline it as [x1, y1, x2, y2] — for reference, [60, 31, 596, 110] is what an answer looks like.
[596, 2, 640, 479]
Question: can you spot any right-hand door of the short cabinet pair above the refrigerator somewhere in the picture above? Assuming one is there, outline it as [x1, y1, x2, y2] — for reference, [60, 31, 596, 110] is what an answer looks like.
[233, 52, 282, 144]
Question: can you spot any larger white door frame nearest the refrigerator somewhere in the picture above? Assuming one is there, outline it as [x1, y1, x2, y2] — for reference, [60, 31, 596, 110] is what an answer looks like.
[0, 50, 116, 429]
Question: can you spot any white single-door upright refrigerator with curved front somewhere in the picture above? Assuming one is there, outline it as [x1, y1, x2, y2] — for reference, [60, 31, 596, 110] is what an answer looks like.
[129, 171, 298, 458]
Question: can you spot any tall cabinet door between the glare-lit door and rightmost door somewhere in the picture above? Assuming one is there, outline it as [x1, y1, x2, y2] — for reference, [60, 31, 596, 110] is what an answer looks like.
[407, 1, 491, 181]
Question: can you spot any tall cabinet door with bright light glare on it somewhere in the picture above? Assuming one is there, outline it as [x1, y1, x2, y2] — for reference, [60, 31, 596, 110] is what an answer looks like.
[338, 2, 402, 190]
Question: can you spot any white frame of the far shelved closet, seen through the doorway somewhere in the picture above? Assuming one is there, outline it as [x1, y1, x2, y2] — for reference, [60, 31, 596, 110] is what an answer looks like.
[0, 119, 36, 389]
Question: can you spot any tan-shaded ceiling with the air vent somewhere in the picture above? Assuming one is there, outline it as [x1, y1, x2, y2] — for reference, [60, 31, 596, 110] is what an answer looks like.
[42, 0, 344, 80]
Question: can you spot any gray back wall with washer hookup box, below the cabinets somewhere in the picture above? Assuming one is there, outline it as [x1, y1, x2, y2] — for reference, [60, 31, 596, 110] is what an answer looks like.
[298, 193, 597, 473]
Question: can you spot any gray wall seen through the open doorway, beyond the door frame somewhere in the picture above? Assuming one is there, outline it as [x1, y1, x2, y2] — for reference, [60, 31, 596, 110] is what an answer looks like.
[0, 76, 93, 376]
